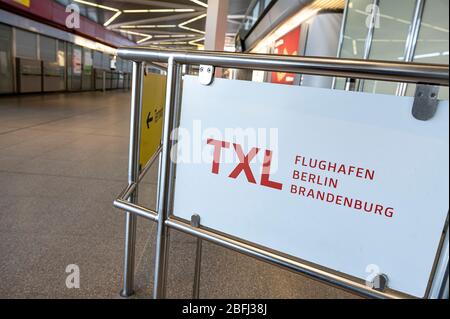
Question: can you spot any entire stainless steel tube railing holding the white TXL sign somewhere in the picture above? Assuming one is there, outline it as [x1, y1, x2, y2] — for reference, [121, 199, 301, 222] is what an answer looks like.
[114, 48, 449, 298]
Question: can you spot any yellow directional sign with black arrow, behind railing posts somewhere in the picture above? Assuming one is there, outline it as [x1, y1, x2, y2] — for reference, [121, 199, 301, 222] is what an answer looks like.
[140, 73, 166, 167]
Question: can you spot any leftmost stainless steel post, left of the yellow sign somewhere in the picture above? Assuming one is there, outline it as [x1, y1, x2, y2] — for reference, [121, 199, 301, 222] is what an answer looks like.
[120, 62, 144, 297]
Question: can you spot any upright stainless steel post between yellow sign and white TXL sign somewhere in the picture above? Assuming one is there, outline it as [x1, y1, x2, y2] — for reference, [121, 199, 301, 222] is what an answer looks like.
[153, 57, 181, 299]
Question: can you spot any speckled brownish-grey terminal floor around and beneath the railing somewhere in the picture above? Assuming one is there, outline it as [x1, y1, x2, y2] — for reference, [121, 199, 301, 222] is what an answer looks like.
[0, 92, 354, 298]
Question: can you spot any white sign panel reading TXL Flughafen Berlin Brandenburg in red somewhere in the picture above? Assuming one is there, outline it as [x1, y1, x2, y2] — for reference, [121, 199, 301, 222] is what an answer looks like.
[174, 76, 449, 297]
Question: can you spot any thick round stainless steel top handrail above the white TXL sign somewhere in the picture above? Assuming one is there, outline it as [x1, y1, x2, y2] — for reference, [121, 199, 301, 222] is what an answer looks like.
[118, 48, 449, 86]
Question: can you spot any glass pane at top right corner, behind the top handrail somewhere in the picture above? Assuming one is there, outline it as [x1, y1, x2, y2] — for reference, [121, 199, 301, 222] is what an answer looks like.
[407, 0, 449, 100]
